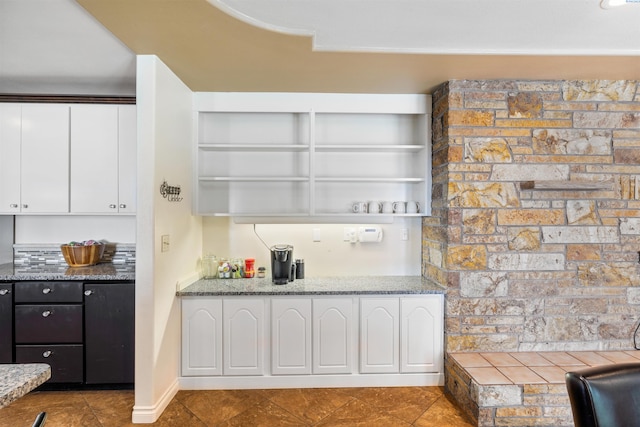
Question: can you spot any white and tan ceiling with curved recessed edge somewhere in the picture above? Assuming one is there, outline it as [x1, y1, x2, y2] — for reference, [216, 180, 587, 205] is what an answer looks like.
[0, 0, 640, 95]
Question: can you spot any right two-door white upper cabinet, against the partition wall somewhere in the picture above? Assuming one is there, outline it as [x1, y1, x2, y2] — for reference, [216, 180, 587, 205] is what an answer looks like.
[70, 104, 135, 214]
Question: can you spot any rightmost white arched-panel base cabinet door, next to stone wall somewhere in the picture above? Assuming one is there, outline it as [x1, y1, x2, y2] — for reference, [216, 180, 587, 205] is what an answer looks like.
[400, 295, 443, 372]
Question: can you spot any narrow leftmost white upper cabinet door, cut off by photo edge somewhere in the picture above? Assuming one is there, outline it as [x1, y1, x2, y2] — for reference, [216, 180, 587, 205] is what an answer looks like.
[0, 104, 22, 213]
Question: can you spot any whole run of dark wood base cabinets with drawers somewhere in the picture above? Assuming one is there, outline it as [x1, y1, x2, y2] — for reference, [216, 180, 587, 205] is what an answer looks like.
[9, 281, 135, 385]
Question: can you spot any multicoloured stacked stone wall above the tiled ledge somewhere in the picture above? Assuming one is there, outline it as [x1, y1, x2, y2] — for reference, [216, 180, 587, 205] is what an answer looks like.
[422, 80, 640, 352]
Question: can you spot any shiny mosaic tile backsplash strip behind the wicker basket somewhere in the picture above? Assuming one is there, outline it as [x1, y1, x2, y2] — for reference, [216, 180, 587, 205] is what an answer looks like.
[13, 243, 136, 265]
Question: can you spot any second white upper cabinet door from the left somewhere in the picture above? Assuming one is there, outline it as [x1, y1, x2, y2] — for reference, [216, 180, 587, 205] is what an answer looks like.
[20, 104, 69, 213]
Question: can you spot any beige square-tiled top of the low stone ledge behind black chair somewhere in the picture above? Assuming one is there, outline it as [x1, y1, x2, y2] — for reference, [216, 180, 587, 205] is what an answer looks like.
[449, 350, 640, 385]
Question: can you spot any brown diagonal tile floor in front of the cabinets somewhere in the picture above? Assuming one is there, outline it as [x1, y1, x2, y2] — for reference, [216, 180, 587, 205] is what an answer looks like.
[0, 387, 473, 427]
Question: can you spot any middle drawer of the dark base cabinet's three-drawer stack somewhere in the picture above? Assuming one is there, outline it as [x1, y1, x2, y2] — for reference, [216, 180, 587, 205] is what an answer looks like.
[15, 304, 83, 344]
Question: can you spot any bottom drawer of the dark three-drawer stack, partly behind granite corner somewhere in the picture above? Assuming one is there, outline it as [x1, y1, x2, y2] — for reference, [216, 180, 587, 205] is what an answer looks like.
[16, 345, 84, 383]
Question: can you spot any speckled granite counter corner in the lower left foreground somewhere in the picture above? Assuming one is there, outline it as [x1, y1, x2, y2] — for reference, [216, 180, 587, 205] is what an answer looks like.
[0, 363, 51, 408]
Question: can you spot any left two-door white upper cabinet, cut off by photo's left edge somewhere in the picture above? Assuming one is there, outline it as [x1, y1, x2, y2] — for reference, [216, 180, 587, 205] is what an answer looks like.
[0, 104, 69, 214]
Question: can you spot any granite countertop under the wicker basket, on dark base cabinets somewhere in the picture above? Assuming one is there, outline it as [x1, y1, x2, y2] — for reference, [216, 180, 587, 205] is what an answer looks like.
[0, 263, 136, 281]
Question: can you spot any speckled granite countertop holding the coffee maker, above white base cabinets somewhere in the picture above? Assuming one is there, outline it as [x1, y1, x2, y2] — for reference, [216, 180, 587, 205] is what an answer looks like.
[176, 276, 445, 297]
